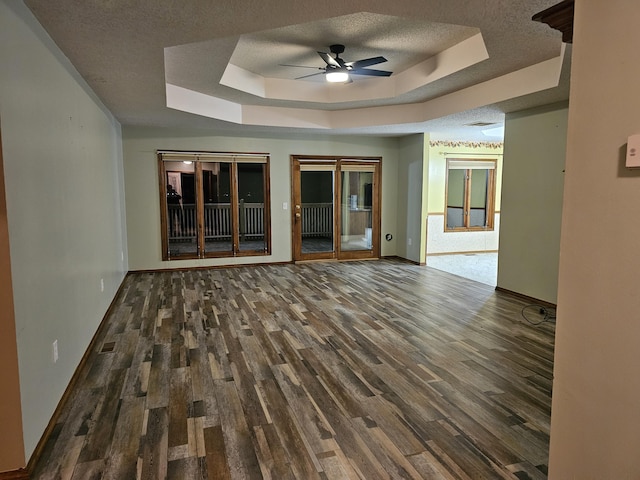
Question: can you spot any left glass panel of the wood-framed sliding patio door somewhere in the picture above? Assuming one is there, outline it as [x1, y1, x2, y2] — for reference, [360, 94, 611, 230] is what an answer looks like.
[300, 170, 335, 254]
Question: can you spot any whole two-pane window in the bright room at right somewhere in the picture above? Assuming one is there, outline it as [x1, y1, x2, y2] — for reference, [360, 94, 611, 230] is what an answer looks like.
[445, 159, 496, 231]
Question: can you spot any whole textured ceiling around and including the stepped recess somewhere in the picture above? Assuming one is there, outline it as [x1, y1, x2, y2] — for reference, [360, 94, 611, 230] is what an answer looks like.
[25, 0, 570, 140]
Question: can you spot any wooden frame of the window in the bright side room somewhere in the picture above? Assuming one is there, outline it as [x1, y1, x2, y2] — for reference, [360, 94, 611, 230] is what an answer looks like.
[444, 158, 498, 232]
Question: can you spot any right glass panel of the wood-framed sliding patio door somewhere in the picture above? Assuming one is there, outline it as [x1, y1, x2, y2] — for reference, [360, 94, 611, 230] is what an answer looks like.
[340, 166, 374, 252]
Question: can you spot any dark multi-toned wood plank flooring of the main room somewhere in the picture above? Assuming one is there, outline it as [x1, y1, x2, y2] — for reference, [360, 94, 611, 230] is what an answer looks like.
[32, 260, 554, 480]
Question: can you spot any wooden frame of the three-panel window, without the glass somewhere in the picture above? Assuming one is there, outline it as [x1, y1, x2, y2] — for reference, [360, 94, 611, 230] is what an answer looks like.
[157, 150, 272, 261]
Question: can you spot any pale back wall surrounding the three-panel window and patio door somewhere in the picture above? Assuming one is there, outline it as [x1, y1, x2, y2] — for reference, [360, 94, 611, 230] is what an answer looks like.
[123, 127, 398, 270]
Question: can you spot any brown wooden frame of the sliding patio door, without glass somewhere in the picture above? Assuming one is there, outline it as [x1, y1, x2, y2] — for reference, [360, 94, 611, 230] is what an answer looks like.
[290, 155, 382, 262]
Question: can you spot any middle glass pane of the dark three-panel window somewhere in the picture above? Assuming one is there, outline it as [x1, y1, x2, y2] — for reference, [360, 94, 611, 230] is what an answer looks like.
[202, 162, 233, 253]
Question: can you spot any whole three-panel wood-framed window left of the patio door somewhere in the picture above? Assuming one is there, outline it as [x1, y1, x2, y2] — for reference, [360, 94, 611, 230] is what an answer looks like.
[158, 151, 271, 260]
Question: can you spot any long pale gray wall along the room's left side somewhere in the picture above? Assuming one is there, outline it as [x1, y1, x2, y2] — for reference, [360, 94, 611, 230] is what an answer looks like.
[0, 0, 127, 458]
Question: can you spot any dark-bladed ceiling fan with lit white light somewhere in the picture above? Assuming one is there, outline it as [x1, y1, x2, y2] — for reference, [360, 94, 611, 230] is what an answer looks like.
[282, 44, 393, 83]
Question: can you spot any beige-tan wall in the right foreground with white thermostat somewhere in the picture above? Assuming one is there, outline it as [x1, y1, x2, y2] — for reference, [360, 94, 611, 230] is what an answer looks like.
[549, 0, 640, 480]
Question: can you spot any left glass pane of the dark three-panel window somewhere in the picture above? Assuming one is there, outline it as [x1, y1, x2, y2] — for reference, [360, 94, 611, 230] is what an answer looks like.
[165, 162, 198, 258]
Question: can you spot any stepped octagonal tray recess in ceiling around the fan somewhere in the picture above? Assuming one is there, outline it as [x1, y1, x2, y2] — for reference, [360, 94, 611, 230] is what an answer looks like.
[165, 12, 564, 129]
